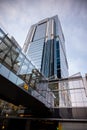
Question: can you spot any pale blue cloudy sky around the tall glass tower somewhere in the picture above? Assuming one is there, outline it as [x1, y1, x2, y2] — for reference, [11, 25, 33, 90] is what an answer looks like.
[0, 0, 87, 76]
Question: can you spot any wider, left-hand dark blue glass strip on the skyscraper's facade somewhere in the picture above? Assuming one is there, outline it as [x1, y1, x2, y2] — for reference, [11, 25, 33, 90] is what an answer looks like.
[41, 40, 54, 77]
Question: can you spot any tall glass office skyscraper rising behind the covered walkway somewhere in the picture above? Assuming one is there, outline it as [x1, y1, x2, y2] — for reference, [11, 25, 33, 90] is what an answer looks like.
[23, 15, 68, 78]
